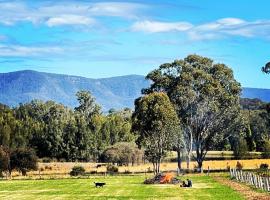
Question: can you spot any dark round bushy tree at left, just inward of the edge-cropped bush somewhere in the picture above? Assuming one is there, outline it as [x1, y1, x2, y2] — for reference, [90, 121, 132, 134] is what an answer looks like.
[10, 148, 37, 176]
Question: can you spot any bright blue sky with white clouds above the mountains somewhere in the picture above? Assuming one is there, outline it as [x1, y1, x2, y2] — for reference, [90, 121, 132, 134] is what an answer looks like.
[0, 0, 270, 88]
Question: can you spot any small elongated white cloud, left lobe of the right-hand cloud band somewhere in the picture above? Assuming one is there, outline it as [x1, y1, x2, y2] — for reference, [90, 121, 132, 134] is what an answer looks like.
[131, 21, 192, 33]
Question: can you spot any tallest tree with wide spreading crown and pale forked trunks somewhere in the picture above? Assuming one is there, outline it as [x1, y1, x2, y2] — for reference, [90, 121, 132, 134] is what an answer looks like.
[143, 55, 241, 168]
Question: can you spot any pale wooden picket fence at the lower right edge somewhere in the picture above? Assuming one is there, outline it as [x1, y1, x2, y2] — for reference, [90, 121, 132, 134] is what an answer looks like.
[230, 169, 270, 192]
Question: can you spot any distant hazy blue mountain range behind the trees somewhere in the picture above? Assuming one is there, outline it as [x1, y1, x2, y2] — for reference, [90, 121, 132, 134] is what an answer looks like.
[0, 70, 270, 111]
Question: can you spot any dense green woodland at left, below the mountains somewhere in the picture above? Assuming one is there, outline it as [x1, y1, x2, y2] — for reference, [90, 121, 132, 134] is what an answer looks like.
[0, 91, 135, 161]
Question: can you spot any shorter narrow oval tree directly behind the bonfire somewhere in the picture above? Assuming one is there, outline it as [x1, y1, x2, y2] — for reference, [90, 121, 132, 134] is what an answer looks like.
[132, 92, 179, 173]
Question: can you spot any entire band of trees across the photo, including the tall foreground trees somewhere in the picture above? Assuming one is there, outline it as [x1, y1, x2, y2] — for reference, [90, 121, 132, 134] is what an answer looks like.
[0, 55, 270, 175]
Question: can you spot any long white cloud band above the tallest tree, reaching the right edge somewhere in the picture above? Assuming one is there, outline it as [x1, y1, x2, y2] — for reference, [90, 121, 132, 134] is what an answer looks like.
[130, 18, 270, 40]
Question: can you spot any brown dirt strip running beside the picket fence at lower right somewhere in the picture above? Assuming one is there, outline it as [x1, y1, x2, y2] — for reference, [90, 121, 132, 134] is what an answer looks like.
[213, 176, 270, 200]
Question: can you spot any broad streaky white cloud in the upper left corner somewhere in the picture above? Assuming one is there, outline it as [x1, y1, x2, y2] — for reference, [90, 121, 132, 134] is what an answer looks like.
[0, 1, 146, 26]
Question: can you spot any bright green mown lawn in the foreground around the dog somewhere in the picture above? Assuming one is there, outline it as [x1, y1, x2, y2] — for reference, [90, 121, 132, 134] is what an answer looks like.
[0, 175, 243, 200]
